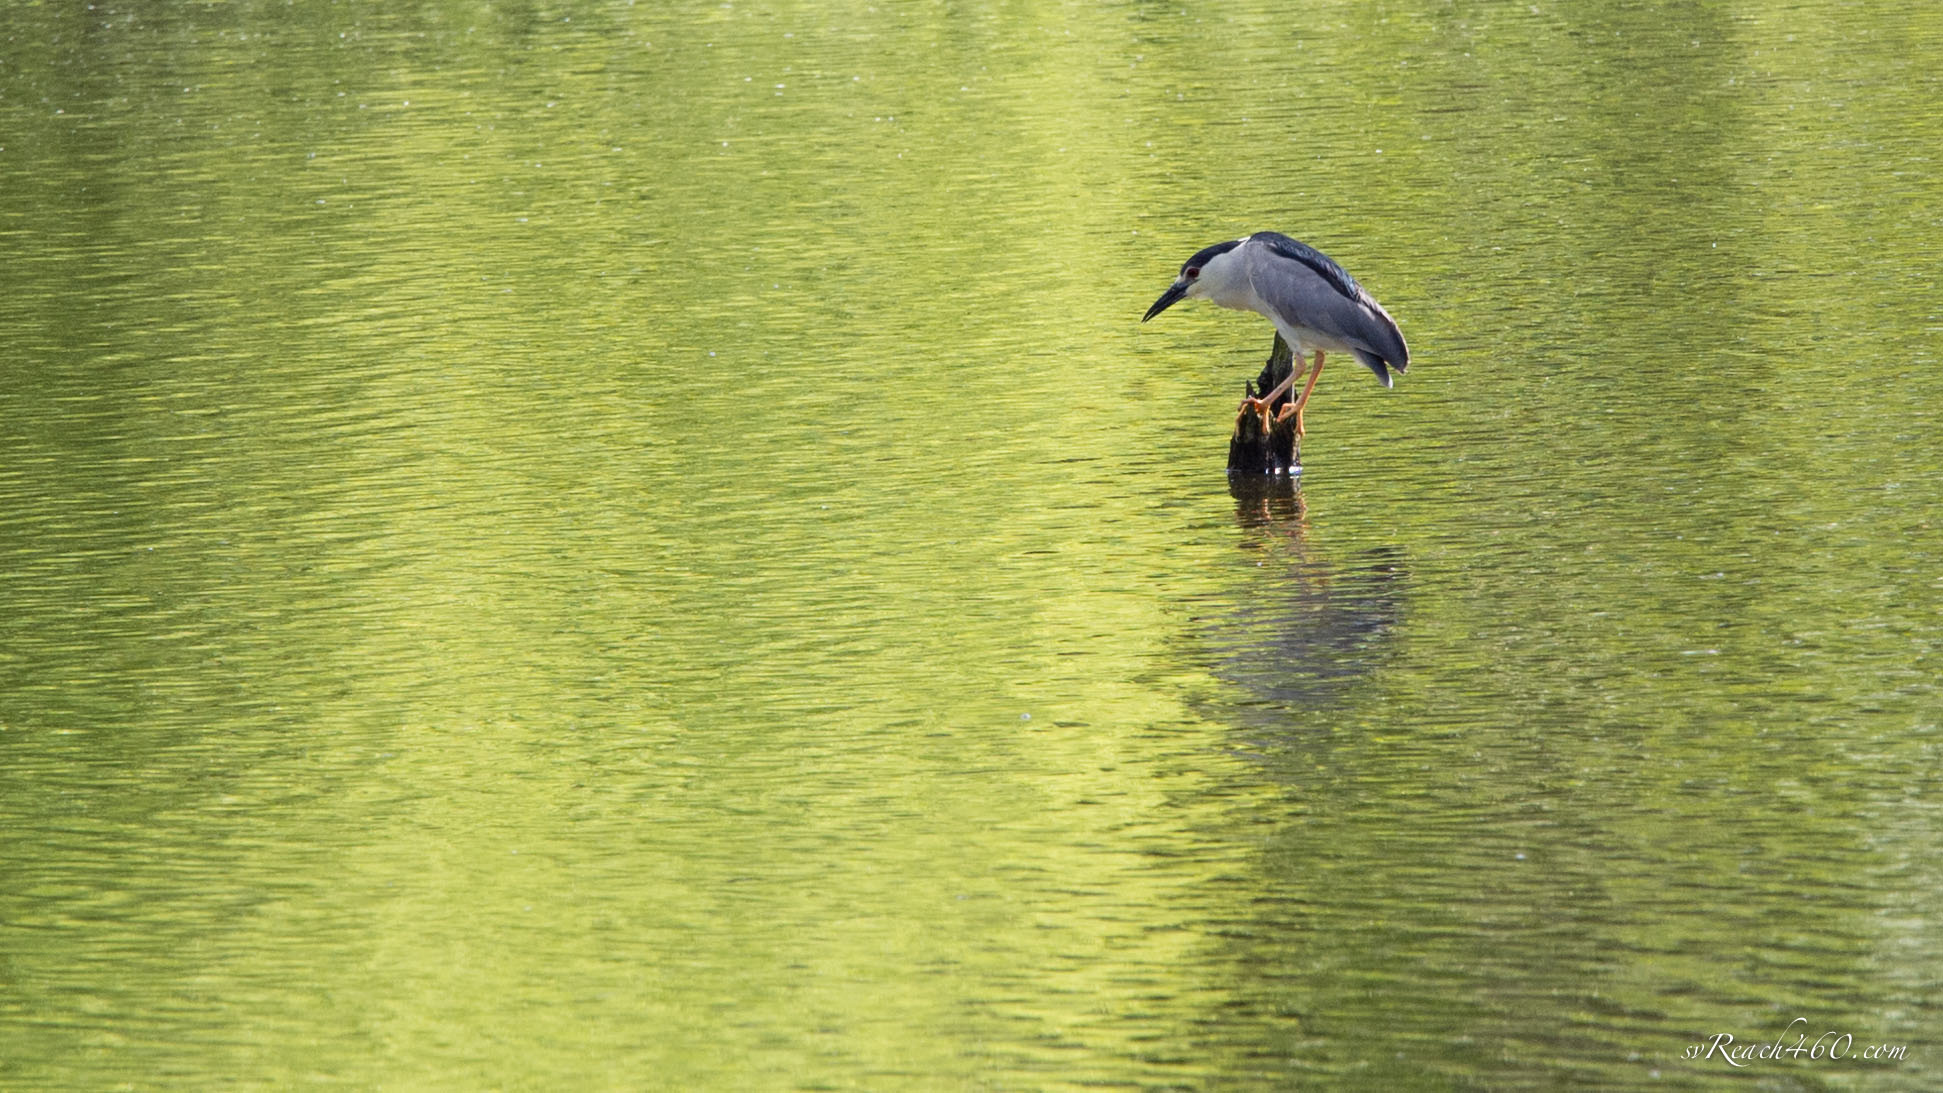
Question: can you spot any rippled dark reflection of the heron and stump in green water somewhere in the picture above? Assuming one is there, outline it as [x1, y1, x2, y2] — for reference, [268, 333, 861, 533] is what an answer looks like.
[1207, 476, 1409, 711]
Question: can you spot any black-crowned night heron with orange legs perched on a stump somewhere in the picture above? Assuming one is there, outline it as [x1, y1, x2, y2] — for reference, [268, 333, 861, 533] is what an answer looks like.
[1141, 231, 1411, 437]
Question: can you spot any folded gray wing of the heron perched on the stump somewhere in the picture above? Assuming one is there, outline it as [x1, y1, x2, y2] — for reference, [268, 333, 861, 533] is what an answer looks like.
[1247, 231, 1411, 386]
